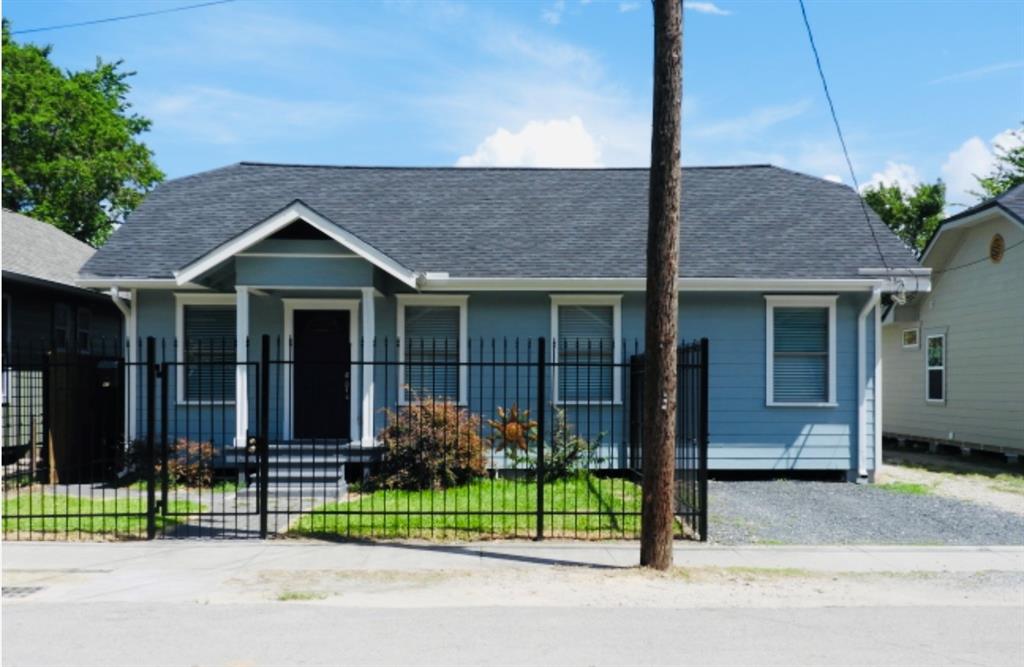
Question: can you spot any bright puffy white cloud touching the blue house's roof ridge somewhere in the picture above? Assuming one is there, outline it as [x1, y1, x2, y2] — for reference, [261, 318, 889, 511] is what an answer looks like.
[456, 116, 602, 167]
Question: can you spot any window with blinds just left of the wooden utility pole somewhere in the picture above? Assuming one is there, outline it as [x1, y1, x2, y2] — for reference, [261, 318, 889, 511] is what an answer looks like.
[557, 304, 615, 403]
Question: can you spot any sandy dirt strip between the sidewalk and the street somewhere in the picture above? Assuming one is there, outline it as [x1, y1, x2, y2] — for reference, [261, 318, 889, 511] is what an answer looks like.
[222, 567, 1024, 608]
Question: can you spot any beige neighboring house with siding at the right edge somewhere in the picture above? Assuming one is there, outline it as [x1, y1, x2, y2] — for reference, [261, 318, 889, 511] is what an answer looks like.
[882, 185, 1024, 461]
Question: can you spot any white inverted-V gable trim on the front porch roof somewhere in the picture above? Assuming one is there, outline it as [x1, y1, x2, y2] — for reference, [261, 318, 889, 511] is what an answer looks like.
[174, 202, 417, 287]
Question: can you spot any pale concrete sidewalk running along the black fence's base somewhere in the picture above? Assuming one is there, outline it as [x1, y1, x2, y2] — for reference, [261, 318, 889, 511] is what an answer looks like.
[8, 540, 1024, 573]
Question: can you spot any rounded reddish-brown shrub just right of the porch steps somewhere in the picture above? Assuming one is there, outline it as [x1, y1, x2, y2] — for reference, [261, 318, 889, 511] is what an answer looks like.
[377, 398, 486, 491]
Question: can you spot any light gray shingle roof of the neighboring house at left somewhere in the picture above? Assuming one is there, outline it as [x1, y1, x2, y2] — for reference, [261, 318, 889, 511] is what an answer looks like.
[3, 209, 96, 286]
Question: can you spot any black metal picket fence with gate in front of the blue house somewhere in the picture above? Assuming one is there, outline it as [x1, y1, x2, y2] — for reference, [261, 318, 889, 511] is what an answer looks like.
[3, 337, 708, 540]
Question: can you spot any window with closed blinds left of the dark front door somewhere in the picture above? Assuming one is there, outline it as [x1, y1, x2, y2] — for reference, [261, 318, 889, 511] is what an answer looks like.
[182, 305, 236, 403]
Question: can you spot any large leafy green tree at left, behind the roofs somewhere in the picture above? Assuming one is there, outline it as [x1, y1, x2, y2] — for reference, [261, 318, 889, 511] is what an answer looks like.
[3, 19, 164, 246]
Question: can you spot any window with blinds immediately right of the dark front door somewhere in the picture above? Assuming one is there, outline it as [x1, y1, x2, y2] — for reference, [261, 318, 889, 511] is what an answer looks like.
[402, 305, 461, 401]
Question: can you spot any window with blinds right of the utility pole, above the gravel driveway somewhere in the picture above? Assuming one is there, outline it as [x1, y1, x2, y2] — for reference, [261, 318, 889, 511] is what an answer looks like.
[772, 306, 829, 403]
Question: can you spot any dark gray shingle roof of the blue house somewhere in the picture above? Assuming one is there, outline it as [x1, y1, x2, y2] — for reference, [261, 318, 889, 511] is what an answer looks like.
[84, 163, 918, 278]
